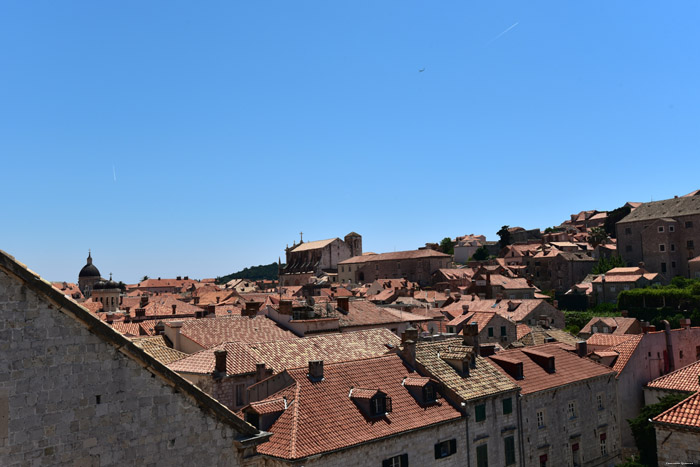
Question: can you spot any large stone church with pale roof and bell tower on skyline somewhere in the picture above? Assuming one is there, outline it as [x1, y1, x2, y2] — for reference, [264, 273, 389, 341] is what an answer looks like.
[279, 232, 362, 286]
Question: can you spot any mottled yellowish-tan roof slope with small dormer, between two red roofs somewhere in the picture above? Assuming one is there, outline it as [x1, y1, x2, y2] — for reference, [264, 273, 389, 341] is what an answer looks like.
[416, 338, 518, 400]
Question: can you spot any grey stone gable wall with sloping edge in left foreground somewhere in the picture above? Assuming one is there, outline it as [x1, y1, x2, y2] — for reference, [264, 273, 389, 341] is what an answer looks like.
[0, 251, 269, 467]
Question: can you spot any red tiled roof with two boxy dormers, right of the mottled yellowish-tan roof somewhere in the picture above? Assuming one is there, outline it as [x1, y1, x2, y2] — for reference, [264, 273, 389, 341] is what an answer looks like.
[488, 343, 614, 394]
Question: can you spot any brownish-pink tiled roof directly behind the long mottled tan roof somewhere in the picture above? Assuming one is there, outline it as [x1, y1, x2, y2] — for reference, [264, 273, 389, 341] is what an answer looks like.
[174, 316, 298, 349]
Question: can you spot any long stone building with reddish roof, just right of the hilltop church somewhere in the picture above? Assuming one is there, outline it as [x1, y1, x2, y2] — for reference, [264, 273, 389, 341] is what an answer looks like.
[338, 249, 452, 286]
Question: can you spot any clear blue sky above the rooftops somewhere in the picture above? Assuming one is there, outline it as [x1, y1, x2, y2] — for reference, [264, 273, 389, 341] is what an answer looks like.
[0, 0, 700, 282]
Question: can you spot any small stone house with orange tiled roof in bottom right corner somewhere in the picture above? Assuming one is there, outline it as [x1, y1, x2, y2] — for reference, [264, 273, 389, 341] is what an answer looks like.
[653, 392, 700, 465]
